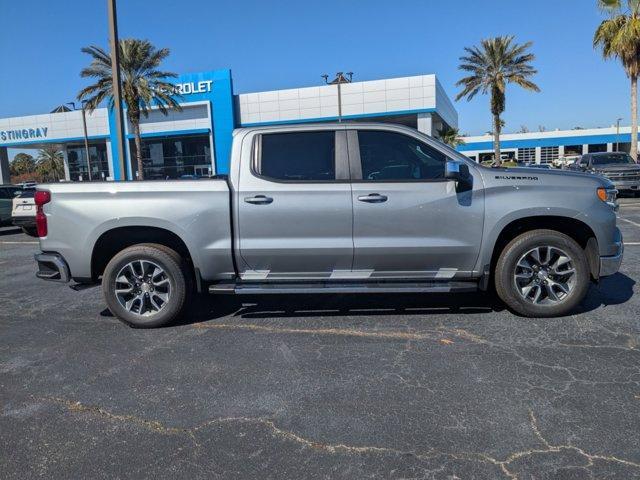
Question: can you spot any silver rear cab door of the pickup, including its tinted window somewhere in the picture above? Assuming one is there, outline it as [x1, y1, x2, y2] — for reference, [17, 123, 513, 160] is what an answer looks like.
[236, 127, 353, 281]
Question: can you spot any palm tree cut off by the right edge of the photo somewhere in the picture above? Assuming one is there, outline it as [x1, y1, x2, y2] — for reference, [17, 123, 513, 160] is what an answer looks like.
[593, 0, 640, 161]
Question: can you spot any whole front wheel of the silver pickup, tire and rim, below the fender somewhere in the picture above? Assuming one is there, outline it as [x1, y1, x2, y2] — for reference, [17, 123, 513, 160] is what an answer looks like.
[495, 230, 590, 317]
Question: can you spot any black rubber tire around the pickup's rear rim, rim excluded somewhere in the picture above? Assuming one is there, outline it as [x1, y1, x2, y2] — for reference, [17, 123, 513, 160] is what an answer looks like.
[102, 243, 191, 328]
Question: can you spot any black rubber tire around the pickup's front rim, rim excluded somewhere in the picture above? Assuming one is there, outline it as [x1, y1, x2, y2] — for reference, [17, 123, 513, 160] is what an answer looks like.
[494, 230, 590, 318]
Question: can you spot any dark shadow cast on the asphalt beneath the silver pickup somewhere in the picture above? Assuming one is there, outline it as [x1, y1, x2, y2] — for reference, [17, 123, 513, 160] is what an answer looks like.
[174, 273, 636, 326]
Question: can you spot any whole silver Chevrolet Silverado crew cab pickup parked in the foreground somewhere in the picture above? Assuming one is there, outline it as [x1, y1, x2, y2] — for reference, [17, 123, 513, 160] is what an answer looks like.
[36, 123, 623, 327]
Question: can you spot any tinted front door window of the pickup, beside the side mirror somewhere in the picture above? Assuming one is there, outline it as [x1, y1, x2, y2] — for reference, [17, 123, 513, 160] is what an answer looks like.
[358, 130, 447, 182]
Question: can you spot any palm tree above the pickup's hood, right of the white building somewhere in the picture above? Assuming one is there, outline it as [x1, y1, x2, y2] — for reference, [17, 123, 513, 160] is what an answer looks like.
[456, 35, 540, 165]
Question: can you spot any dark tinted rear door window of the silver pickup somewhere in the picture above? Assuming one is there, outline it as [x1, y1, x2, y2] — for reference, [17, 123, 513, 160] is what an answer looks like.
[256, 131, 336, 181]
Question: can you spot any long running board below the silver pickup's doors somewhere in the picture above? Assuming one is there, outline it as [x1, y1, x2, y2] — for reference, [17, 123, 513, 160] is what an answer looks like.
[209, 281, 478, 295]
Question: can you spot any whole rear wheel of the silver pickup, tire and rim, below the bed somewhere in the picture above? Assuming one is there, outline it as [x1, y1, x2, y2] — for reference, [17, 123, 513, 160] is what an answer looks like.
[102, 244, 189, 328]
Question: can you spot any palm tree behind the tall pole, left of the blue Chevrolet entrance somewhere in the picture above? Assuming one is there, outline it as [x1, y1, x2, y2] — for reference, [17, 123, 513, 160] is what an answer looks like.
[78, 38, 181, 180]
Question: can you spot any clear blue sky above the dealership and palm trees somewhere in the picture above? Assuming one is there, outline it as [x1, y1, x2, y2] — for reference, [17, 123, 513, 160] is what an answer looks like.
[0, 0, 630, 134]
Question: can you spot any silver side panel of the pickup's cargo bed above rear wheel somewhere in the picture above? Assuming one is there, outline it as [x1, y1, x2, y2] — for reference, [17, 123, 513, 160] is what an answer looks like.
[39, 179, 235, 280]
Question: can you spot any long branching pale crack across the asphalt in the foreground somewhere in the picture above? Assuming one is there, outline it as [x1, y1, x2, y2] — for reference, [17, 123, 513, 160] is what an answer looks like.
[41, 397, 640, 480]
